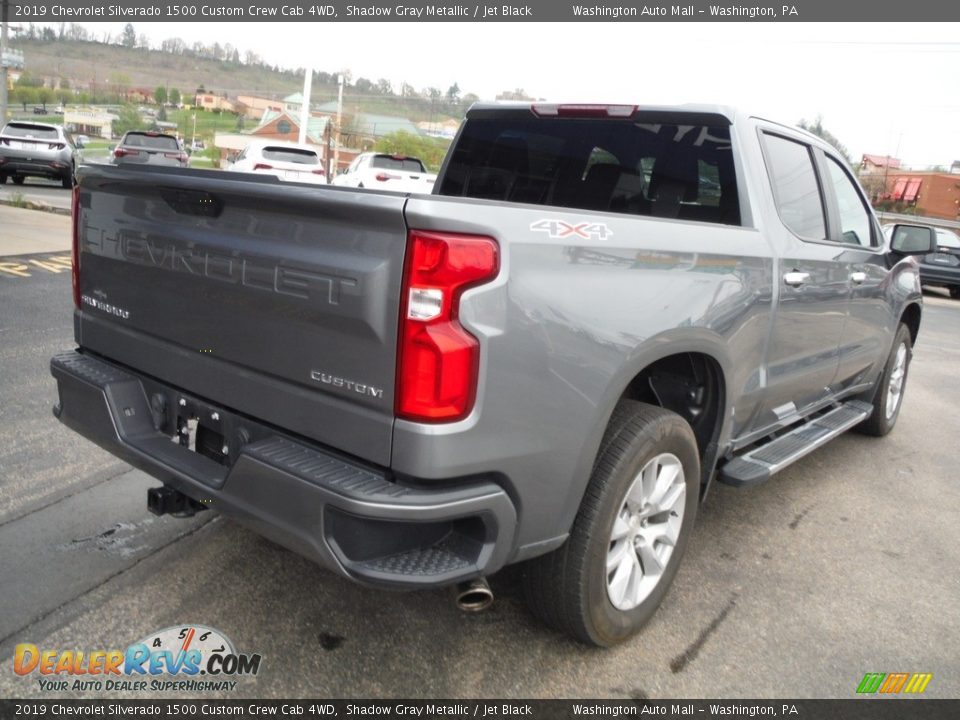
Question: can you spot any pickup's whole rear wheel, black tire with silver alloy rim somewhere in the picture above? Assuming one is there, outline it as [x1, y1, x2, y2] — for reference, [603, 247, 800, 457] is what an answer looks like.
[524, 400, 700, 647]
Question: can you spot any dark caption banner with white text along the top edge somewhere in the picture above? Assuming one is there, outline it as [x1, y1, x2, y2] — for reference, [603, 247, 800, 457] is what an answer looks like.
[9, 0, 960, 23]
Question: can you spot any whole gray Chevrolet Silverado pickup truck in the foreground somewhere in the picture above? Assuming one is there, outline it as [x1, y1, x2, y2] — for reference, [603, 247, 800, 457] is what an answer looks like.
[52, 104, 931, 646]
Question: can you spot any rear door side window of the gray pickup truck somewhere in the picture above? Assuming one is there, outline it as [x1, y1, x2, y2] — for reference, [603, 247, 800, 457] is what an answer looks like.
[764, 134, 827, 240]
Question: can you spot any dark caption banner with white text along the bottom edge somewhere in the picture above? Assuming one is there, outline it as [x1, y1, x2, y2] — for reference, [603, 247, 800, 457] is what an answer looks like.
[0, 697, 960, 720]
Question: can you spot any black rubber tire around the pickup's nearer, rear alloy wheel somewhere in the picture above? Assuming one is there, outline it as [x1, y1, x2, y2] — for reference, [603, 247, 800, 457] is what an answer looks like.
[523, 400, 700, 647]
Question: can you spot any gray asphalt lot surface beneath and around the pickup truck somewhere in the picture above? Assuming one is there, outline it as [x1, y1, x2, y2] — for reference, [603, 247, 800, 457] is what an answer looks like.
[0, 208, 960, 698]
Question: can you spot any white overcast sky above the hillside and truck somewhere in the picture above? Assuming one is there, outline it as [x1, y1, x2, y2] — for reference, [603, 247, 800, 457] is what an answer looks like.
[65, 22, 960, 167]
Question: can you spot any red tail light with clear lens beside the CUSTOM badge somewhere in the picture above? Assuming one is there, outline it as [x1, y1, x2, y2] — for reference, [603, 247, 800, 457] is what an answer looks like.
[396, 230, 500, 422]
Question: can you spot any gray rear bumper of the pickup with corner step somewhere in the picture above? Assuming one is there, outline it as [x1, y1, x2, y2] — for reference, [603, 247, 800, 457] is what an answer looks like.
[50, 352, 516, 588]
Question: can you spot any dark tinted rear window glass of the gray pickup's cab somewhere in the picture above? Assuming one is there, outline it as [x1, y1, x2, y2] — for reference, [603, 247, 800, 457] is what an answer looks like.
[439, 116, 740, 225]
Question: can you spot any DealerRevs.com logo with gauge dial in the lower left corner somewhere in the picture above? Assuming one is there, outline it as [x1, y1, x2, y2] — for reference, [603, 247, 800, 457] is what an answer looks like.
[13, 625, 261, 692]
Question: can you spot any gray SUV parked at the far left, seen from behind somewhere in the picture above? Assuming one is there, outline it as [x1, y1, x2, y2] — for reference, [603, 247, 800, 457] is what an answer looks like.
[0, 120, 83, 188]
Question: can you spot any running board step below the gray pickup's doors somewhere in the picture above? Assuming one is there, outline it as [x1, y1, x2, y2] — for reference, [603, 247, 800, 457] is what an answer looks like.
[717, 400, 873, 487]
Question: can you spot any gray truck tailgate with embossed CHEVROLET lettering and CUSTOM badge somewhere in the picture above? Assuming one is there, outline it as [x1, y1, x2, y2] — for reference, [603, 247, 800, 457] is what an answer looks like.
[77, 166, 406, 465]
